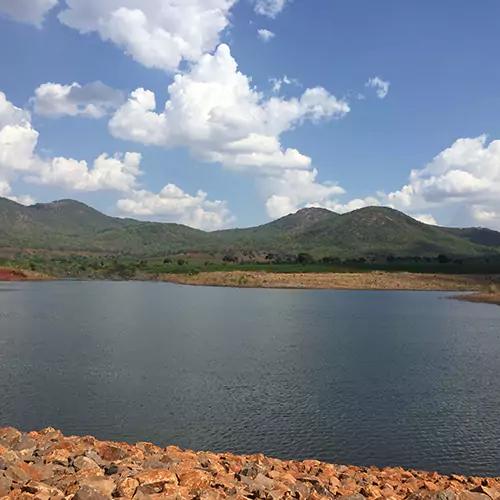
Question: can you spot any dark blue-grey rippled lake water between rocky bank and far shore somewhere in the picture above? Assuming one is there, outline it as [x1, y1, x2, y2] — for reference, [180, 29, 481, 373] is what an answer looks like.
[0, 282, 500, 475]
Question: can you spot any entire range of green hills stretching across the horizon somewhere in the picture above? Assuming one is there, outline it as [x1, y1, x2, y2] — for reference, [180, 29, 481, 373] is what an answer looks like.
[0, 198, 500, 257]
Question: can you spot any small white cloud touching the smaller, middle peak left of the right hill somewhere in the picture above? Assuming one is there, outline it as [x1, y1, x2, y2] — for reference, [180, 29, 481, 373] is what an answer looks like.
[260, 169, 345, 219]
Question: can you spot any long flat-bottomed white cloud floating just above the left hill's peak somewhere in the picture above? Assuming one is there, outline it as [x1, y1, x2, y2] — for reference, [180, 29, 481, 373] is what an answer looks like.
[26, 153, 142, 192]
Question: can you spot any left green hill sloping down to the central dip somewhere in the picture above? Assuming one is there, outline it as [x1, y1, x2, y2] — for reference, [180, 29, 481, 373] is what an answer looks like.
[0, 198, 208, 254]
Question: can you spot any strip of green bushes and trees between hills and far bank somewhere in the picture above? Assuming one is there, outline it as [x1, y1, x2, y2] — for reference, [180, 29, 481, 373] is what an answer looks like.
[0, 249, 500, 280]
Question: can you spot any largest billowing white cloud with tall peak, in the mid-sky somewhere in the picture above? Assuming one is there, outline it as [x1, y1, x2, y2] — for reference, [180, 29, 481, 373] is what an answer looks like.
[109, 44, 350, 173]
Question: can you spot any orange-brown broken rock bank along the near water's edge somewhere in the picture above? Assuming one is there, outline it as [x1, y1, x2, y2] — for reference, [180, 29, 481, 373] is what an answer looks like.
[0, 427, 500, 500]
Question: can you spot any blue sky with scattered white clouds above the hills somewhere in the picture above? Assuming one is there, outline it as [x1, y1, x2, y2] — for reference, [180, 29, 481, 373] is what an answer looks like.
[0, 0, 500, 231]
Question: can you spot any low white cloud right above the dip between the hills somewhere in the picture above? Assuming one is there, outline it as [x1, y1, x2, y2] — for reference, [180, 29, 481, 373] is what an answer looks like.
[117, 184, 235, 231]
